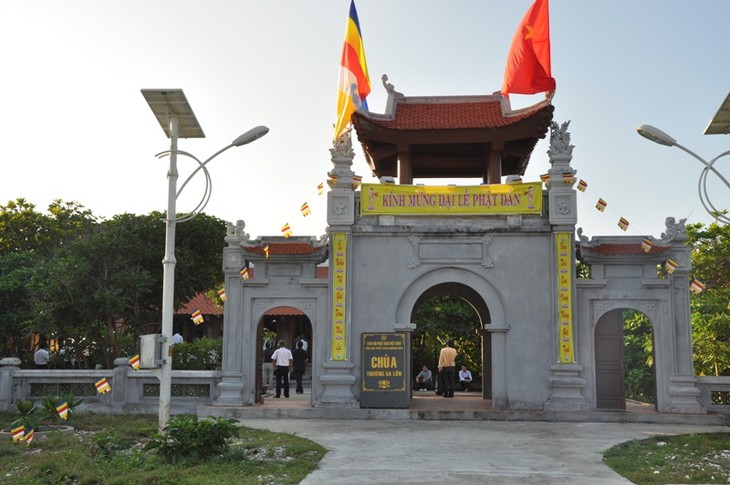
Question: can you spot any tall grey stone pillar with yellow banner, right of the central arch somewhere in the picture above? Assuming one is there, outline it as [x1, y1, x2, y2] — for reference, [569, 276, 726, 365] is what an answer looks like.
[545, 121, 590, 411]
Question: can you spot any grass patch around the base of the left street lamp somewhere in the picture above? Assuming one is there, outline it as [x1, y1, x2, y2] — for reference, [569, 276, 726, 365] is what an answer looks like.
[0, 413, 325, 485]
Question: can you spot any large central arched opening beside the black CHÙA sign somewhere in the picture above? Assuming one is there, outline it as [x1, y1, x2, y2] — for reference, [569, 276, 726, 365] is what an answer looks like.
[411, 282, 492, 399]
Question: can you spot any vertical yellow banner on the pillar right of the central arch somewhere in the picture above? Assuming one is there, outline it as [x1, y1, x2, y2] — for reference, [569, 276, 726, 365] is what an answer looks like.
[555, 232, 575, 364]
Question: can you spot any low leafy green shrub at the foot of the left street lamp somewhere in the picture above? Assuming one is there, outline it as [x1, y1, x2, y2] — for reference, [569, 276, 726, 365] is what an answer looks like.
[145, 414, 239, 463]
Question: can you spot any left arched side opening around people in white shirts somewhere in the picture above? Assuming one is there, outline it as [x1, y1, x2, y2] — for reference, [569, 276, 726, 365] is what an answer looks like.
[256, 306, 313, 402]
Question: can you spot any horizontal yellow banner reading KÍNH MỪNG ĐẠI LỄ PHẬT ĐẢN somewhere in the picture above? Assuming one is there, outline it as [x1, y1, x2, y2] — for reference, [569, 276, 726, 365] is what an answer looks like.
[360, 182, 542, 215]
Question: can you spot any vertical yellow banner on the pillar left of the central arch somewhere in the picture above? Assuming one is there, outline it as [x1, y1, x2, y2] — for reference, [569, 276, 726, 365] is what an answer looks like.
[330, 232, 347, 360]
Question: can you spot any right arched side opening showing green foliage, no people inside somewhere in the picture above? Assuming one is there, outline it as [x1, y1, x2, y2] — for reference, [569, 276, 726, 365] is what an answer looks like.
[594, 308, 656, 410]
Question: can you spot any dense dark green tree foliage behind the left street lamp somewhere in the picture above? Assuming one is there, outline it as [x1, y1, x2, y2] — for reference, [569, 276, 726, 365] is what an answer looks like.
[0, 199, 226, 367]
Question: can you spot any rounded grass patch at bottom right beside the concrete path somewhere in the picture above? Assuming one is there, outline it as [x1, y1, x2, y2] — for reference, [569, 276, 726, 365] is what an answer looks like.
[603, 433, 730, 485]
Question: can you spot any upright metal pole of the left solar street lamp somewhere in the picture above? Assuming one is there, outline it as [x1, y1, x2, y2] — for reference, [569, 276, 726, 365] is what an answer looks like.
[158, 116, 178, 433]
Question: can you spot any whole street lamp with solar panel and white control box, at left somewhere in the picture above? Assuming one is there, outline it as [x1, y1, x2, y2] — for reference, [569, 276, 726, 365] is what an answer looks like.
[141, 89, 269, 433]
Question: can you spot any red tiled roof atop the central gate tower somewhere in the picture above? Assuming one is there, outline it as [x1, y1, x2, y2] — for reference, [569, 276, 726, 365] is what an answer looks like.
[356, 99, 536, 130]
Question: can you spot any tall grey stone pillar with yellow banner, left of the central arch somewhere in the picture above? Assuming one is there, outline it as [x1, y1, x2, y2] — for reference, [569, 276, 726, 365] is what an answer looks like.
[312, 127, 360, 408]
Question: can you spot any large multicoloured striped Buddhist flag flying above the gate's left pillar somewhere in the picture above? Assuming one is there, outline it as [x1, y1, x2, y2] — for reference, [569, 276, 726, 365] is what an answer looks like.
[335, 0, 370, 139]
